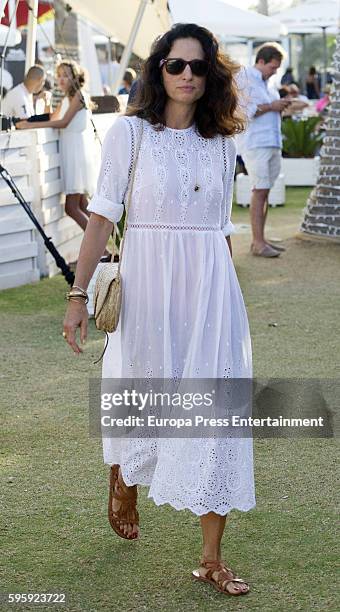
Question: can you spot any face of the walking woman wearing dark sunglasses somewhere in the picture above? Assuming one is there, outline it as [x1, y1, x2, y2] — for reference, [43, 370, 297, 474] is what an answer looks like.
[161, 38, 206, 105]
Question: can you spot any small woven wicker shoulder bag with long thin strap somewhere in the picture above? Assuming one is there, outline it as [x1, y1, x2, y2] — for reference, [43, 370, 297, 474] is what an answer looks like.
[94, 120, 143, 332]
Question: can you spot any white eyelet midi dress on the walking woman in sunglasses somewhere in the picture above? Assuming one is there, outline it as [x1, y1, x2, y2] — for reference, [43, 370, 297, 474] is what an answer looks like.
[88, 117, 255, 515]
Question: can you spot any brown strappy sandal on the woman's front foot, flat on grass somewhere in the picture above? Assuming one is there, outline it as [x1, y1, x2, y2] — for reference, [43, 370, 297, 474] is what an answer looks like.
[192, 561, 249, 596]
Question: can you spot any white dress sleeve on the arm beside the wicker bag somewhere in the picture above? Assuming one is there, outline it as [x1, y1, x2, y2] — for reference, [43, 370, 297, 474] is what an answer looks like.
[87, 117, 132, 222]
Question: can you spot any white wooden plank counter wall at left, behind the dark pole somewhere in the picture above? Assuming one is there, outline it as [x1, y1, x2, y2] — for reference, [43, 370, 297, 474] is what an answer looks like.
[0, 114, 117, 289]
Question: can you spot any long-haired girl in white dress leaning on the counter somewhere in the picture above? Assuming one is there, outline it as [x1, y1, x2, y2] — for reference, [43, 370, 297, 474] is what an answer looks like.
[16, 60, 102, 244]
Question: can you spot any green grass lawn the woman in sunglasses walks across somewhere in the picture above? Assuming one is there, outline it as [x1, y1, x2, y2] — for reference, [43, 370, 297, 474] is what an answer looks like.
[0, 189, 340, 612]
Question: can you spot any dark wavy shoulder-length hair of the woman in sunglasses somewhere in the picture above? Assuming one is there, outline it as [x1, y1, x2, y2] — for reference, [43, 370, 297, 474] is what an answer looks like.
[126, 23, 245, 138]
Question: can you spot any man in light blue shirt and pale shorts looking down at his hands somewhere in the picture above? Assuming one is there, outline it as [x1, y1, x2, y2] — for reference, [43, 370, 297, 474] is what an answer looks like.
[237, 43, 290, 257]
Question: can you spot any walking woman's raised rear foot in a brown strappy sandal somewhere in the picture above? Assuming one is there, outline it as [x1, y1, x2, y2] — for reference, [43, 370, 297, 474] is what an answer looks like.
[108, 465, 139, 540]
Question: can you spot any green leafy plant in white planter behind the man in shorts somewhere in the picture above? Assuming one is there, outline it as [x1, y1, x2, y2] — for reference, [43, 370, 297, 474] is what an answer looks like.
[282, 117, 323, 186]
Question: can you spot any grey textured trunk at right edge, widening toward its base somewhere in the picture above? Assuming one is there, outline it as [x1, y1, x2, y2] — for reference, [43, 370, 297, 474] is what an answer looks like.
[300, 35, 340, 240]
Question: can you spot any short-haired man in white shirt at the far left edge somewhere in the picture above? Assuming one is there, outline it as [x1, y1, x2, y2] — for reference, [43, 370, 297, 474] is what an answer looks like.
[2, 66, 48, 119]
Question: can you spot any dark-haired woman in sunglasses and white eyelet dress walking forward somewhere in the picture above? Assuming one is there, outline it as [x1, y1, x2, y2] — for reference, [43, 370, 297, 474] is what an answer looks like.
[63, 24, 255, 595]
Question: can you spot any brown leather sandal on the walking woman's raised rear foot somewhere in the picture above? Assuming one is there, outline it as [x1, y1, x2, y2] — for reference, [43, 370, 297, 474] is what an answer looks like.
[108, 465, 139, 540]
